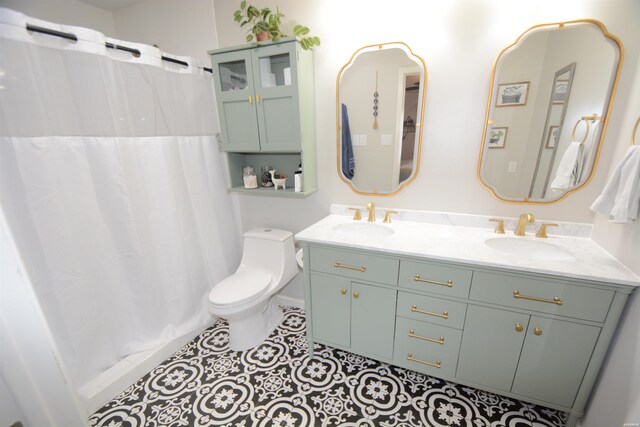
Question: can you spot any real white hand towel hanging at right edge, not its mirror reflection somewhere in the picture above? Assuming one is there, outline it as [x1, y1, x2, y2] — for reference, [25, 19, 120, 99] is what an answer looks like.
[591, 145, 640, 224]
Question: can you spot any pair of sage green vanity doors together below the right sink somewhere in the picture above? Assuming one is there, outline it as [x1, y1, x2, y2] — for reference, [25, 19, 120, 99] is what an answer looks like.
[456, 305, 600, 407]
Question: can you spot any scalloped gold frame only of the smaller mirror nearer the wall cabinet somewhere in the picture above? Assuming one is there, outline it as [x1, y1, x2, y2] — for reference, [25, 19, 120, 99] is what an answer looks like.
[336, 42, 428, 197]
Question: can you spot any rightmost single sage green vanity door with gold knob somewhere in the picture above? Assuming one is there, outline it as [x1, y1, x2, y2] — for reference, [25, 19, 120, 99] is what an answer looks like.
[511, 316, 600, 407]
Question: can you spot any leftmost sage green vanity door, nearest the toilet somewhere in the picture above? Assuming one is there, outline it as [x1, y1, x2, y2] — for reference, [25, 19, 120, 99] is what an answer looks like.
[311, 274, 351, 347]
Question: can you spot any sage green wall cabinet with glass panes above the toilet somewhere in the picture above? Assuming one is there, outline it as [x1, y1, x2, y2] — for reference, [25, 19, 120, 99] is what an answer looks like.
[209, 38, 317, 197]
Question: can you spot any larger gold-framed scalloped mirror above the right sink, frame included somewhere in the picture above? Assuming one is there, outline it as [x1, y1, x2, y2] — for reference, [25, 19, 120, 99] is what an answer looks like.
[478, 19, 623, 203]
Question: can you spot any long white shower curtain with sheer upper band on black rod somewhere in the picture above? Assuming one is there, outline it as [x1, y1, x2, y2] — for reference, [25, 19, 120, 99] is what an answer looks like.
[0, 8, 241, 387]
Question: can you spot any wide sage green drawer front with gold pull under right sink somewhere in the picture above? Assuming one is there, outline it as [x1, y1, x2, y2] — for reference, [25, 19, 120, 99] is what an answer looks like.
[469, 272, 614, 322]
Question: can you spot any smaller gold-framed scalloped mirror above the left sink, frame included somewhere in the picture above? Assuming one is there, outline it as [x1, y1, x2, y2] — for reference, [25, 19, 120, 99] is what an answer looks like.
[336, 42, 427, 196]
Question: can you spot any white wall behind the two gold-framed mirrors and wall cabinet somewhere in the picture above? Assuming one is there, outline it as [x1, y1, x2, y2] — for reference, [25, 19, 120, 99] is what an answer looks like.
[215, 0, 640, 231]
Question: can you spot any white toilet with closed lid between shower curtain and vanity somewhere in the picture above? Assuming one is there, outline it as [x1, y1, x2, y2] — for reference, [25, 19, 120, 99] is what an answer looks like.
[209, 228, 298, 351]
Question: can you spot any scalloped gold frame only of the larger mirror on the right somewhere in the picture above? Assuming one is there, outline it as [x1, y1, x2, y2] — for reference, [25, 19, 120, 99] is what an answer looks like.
[477, 19, 624, 205]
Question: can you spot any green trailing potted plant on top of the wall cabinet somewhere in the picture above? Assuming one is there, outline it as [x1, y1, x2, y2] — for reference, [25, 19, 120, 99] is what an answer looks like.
[233, 0, 320, 50]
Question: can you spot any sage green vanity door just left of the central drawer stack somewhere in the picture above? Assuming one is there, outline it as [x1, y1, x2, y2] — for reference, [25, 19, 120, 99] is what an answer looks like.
[351, 282, 396, 359]
